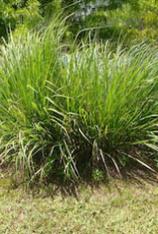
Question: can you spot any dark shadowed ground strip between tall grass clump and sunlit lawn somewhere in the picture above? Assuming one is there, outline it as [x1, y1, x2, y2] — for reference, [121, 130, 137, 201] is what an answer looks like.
[4, 162, 158, 200]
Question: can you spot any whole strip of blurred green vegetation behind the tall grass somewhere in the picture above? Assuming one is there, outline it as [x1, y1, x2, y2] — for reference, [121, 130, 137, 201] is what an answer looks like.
[0, 0, 158, 44]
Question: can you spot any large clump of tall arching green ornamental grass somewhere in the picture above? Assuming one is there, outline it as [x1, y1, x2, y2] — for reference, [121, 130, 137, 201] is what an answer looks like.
[0, 22, 158, 183]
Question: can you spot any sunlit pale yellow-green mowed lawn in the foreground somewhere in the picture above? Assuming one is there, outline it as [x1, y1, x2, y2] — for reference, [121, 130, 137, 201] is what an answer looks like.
[0, 180, 158, 234]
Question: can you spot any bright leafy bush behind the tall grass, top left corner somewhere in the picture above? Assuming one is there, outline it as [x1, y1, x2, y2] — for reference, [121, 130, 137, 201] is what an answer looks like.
[0, 0, 41, 38]
